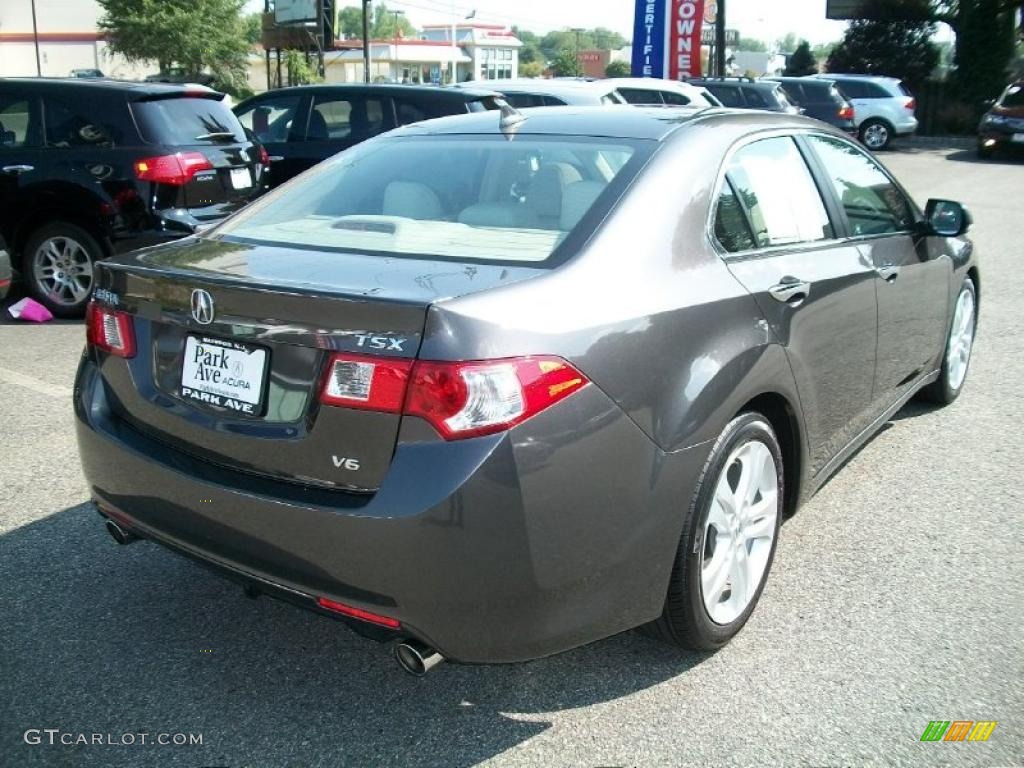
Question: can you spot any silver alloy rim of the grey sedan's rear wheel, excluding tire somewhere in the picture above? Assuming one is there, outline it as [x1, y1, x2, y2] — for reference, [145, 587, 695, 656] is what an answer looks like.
[700, 440, 779, 625]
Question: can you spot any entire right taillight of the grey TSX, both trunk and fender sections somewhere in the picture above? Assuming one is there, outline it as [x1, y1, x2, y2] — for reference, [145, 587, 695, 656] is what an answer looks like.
[319, 353, 589, 440]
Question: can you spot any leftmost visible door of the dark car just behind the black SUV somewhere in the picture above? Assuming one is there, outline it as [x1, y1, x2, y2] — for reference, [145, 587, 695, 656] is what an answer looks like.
[234, 92, 311, 187]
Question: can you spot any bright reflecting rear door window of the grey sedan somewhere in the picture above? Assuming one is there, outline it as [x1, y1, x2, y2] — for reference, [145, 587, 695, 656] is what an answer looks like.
[726, 136, 835, 248]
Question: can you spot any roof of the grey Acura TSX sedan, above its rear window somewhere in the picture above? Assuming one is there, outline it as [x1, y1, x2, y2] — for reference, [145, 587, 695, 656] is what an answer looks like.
[386, 104, 822, 141]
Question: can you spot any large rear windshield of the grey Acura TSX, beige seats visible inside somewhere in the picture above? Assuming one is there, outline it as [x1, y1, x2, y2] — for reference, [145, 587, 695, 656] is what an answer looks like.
[209, 134, 650, 263]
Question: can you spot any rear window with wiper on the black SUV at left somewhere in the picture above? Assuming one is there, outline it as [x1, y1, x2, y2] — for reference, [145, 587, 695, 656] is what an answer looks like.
[131, 97, 246, 146]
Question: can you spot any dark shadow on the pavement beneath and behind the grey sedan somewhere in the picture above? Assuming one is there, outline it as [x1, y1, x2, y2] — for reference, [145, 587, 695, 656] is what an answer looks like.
[0, 504, 707, 768]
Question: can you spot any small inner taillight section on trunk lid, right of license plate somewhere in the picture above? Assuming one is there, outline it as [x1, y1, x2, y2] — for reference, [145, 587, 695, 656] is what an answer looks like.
[319, 353, 413, 414]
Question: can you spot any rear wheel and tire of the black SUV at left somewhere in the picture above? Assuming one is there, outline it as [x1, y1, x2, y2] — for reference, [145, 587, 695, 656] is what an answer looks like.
[22, 221, 105, 317]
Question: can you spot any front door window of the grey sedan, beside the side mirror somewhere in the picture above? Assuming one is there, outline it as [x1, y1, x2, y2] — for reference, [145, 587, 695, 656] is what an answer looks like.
[808, 136, 915, 236]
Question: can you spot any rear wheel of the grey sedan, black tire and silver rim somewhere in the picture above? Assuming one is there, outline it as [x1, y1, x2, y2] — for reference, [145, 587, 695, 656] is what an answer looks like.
[648, 413, 784, 650]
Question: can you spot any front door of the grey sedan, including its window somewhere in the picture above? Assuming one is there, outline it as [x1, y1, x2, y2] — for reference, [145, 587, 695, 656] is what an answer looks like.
[807, 136, 952, 410]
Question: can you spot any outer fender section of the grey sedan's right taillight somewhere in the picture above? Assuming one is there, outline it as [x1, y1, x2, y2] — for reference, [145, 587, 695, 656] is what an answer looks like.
[404, 356, 589, 440]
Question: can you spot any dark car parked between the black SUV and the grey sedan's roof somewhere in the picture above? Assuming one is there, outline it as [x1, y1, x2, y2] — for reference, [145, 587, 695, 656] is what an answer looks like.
[234, 84, 498, 186]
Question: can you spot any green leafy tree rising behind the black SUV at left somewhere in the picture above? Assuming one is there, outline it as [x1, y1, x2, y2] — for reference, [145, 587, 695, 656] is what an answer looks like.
[97, 0, 252, 95]
